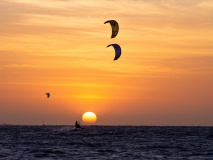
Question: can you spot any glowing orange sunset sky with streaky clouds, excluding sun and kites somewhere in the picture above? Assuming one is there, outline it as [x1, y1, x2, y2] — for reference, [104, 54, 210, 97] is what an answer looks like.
[0, 0, 213, 126]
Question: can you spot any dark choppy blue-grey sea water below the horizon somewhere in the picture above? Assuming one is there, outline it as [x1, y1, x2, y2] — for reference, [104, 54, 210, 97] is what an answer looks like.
[0, 126, 213, 160]
